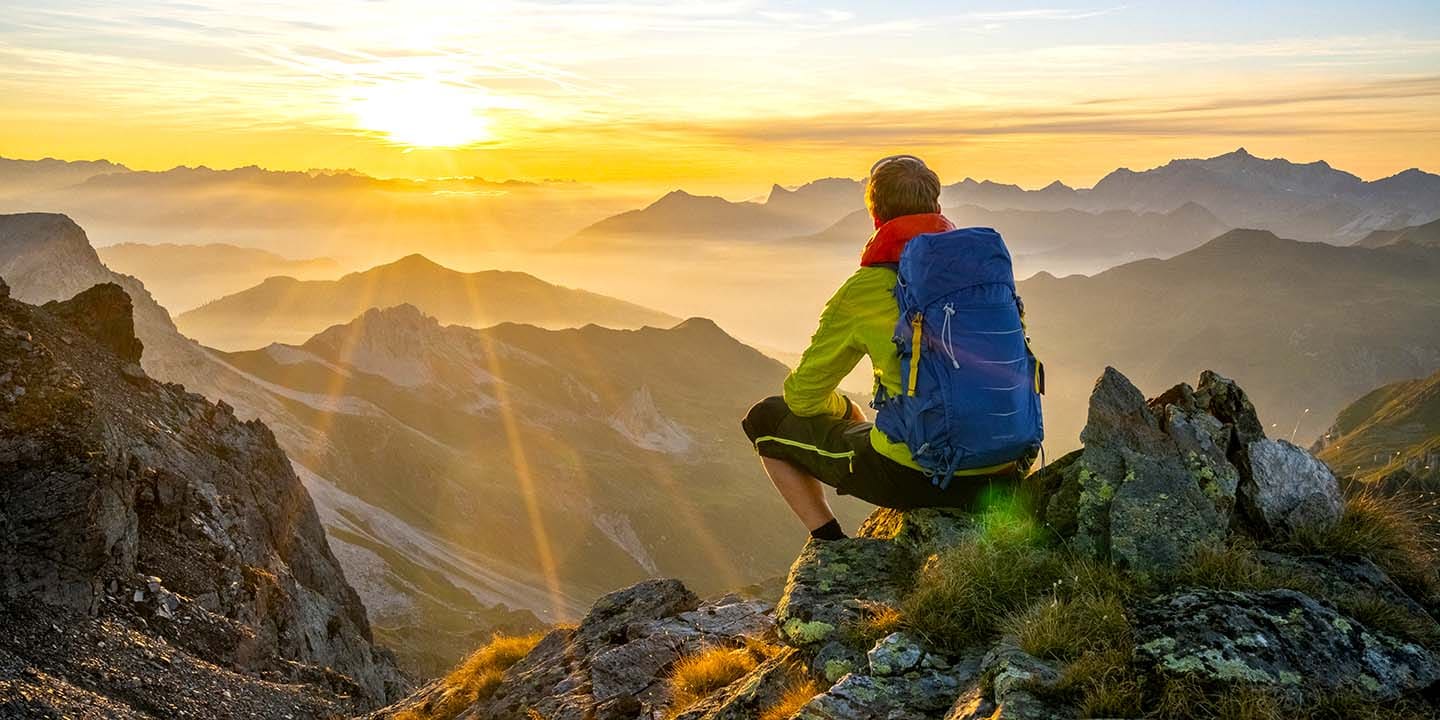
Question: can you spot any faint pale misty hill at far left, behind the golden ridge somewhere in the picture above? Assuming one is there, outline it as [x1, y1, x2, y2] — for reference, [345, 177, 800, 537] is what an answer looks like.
[96, 242, 340, 312]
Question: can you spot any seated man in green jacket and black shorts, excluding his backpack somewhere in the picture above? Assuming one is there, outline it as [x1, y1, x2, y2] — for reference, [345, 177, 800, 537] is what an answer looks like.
[742, 156, 1020, 540]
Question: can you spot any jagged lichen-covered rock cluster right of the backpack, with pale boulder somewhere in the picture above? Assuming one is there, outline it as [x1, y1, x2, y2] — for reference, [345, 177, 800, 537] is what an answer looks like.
[1028, 367, 1342, 575]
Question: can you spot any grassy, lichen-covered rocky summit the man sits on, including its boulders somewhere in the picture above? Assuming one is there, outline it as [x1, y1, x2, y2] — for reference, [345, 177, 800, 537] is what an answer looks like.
[376, 370, 1440, 720]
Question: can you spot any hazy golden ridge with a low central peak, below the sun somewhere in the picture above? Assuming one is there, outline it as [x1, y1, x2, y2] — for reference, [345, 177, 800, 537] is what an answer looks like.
[177, 255, 675, 350]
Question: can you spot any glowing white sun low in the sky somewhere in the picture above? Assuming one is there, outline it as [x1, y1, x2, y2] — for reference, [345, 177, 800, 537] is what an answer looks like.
[351, 81, 494, 147]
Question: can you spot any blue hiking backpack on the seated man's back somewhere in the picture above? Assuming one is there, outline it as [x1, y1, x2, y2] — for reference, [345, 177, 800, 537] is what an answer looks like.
[874, 228, 1045, 488]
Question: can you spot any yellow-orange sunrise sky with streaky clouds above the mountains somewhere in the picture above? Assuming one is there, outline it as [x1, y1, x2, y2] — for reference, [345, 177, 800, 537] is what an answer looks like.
[0, 0, 1440, 197]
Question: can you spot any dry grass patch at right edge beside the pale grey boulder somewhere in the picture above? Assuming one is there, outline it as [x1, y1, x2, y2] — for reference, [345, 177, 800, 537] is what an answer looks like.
[1283, 487, 1437, 598]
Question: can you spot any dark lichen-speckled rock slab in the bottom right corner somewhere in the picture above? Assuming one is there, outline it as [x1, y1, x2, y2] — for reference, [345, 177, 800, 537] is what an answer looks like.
[1135, 590, 1440, 701]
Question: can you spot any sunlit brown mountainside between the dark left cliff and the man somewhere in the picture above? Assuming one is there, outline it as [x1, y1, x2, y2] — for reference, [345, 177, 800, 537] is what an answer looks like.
[213, 305, 854, 673]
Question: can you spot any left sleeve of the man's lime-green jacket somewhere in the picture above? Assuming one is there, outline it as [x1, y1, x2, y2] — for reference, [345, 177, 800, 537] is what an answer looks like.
[785, 282, 865, 418]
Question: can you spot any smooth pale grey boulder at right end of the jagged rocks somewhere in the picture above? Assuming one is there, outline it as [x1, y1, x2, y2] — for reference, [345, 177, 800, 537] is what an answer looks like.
[1240, 439, 1345, 534]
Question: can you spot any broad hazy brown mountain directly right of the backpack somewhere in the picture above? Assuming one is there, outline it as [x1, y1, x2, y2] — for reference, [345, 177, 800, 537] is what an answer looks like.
[1020, 230, 1440, 449]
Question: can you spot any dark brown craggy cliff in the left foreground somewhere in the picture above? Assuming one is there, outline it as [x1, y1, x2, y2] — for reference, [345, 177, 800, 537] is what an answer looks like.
[0, 285, 409, 708]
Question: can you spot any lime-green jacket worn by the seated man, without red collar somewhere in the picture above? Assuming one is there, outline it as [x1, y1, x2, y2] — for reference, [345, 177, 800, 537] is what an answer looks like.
[785, 266, 922, 469]
